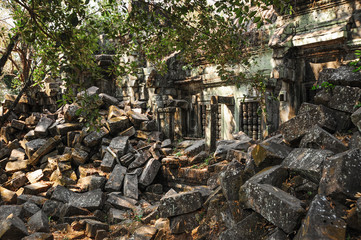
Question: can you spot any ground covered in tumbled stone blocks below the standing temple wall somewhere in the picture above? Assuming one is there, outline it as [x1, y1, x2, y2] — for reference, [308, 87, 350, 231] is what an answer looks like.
[0, 66, 361, 240]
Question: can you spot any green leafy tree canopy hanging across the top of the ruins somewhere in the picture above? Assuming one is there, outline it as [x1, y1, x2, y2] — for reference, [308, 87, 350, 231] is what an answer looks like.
[2, 0, 293, 125]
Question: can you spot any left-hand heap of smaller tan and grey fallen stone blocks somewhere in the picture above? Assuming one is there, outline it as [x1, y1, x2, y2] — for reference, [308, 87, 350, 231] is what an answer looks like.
[0, 87, 217, 239]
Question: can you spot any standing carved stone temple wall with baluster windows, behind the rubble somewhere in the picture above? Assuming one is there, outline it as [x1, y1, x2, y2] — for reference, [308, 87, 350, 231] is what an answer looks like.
[95, 0, 361, 150]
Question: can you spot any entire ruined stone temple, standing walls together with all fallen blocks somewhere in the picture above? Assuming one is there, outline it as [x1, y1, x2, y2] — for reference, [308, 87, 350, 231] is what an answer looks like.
[0, 1, 361, 240]
